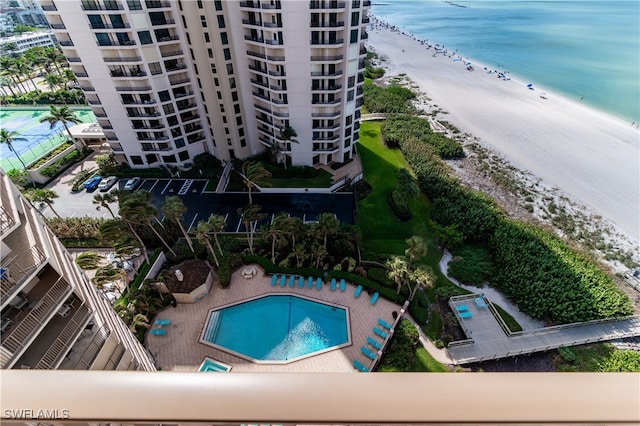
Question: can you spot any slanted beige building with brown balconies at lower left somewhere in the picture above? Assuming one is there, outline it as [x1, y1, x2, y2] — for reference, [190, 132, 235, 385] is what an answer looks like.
[0, 171, 155, 371]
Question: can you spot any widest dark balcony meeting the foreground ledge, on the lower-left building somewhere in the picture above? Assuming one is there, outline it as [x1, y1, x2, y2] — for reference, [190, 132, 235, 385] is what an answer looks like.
[9, 294, 91, 370]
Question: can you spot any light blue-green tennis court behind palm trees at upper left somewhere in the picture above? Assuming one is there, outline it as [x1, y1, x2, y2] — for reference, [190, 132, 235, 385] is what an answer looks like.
[0, 107, 96, 171]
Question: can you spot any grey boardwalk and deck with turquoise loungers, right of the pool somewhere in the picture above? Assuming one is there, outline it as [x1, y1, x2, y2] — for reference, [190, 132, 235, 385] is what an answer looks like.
[447, 295, 640, 364]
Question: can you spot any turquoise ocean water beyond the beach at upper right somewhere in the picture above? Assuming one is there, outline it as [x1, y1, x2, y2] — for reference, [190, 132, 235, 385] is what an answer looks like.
[371, 0, 640, 123]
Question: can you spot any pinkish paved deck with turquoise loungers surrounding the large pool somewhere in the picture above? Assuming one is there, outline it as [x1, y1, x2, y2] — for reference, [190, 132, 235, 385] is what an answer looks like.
[145, 265, 401, 374]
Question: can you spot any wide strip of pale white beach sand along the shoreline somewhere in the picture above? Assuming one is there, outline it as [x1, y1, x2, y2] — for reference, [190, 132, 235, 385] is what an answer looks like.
[368, 19, 640, 244]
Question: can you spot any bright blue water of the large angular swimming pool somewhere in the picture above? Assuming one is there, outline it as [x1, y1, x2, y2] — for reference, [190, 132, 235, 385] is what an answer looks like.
[203, 295, 349, 361]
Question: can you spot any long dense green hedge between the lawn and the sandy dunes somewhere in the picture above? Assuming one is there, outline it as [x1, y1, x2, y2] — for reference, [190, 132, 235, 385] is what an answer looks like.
[400, 125, 632, 324]
